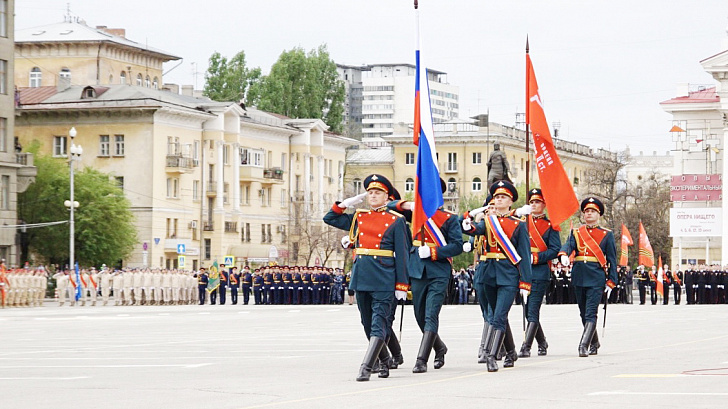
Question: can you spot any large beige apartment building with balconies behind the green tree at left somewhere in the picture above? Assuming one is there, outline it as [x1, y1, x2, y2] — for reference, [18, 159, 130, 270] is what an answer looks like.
[10, 18, 358, 269]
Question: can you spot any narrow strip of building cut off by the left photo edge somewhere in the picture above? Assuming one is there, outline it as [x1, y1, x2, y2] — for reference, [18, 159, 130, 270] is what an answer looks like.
[0, 0, 36, 265]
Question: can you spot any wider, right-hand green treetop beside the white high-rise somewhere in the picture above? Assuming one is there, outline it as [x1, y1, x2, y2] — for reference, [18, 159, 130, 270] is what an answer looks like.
[249, 45, 346, 132]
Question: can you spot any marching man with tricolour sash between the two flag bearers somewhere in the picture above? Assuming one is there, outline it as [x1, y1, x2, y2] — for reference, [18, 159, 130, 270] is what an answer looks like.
[462, 180, 531, 372]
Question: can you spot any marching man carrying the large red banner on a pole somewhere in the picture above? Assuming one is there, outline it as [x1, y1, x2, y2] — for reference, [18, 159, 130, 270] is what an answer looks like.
[518, 188, 561, 358]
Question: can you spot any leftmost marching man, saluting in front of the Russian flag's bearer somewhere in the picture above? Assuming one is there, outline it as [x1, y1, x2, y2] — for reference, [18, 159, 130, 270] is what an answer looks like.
[324, 174, 411, 381]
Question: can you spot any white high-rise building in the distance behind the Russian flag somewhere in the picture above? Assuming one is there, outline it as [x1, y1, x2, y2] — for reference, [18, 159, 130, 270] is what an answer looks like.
[339, 64, 460, 140]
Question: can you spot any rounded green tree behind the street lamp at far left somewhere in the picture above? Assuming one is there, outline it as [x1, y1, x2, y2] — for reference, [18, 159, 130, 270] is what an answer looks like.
[18, 155, 137, 266]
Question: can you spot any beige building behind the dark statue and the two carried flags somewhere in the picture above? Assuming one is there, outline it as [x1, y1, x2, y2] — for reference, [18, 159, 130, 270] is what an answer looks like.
[346, 120, 614, 212]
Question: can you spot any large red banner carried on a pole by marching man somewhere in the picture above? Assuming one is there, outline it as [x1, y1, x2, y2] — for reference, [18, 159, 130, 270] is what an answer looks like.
[526, 53, 579, 230]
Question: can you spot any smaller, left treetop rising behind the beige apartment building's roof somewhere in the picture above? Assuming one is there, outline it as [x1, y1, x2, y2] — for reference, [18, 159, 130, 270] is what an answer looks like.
[203, 51, 261, 102]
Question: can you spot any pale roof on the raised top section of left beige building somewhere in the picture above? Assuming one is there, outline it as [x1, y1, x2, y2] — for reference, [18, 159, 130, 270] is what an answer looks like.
[15, 20, 182, 61]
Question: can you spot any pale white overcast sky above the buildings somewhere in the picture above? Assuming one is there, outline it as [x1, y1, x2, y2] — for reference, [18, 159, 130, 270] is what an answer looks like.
[15, 0, 728, 154]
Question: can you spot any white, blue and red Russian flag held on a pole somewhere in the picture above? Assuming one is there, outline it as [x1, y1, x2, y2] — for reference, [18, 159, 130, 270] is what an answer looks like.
[412, 10, 445, 234]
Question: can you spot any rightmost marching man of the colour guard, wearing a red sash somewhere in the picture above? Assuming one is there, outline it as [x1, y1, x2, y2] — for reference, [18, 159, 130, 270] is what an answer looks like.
[559, 197, 617, 357]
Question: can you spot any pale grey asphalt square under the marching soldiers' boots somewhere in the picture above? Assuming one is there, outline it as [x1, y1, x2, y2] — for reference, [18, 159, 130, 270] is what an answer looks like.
[0, 302, 728, 409]
